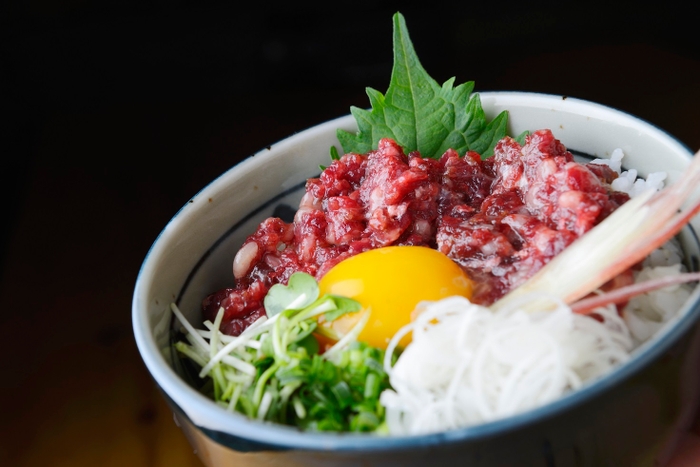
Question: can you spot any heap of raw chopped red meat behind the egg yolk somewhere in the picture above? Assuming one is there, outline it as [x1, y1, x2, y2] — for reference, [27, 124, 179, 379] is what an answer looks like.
[202, 130, 629, 335]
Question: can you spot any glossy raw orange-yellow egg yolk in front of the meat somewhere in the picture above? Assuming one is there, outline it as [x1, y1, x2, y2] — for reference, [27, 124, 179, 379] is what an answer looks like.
[319, 246, 472, 349]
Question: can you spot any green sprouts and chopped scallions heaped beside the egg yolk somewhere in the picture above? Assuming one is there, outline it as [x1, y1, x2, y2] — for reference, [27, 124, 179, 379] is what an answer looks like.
[171, 273, 388, 432]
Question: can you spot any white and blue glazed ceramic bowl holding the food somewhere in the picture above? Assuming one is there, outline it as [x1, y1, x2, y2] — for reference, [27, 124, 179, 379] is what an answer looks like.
[133, 92, 700, 467]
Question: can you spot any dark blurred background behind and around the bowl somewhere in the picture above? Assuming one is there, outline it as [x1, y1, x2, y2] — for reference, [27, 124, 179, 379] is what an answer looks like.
[0, 0, 700, 467]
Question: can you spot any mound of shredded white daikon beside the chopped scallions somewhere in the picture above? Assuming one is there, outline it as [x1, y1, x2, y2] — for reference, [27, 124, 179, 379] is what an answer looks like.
[381, 296, 633, 435]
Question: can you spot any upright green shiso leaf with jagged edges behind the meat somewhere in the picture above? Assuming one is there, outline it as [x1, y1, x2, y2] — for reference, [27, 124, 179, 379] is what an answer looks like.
[332, 13, 508, 158]
